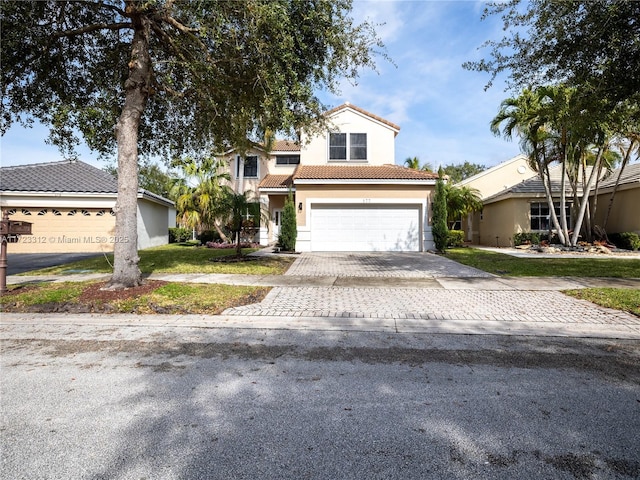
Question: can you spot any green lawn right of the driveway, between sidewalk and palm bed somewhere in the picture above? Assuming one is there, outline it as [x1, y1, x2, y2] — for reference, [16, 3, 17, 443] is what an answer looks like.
[445, 248, 640, 278]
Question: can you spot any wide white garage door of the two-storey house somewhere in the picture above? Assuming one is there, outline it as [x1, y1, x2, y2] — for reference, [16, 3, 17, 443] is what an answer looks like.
[311, 204, 420, 252]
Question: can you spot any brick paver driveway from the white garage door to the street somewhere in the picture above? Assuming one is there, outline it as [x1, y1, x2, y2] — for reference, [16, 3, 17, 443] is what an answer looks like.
[223, 253, 640, 336]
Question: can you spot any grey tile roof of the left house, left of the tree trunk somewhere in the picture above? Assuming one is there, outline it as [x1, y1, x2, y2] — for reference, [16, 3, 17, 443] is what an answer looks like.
[0, 161, 118, 193]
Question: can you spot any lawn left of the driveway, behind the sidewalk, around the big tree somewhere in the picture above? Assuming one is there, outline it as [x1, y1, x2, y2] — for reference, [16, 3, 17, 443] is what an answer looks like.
[23, 243, 294, 275]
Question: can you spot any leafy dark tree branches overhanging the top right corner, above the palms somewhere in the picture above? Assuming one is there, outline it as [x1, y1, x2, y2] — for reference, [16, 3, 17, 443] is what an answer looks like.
[464, 0, 640, 110]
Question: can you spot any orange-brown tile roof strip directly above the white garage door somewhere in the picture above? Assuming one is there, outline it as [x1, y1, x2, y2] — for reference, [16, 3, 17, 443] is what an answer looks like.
[293, 165, 438, 182]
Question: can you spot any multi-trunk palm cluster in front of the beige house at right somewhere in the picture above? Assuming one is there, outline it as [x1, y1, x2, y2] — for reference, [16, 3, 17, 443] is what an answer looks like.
[490, 84, 638, 246]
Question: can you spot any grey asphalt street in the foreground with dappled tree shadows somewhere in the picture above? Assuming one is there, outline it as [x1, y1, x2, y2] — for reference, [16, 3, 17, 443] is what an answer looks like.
[0, 322, 640, 480]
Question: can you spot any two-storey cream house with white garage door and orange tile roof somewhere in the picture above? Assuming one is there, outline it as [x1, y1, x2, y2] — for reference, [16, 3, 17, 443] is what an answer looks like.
[222, 103, 437, 252]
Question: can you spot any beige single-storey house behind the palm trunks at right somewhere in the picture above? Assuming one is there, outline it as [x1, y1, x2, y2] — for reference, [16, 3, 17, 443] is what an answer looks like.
[459, 155, 640, 247]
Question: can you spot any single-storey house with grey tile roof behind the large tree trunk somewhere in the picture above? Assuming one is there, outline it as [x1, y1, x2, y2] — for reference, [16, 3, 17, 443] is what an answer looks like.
[0, 161, 176, 253]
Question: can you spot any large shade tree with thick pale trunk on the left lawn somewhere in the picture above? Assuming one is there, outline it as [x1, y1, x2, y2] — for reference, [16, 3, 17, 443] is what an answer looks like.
[0, 0, 381, 288]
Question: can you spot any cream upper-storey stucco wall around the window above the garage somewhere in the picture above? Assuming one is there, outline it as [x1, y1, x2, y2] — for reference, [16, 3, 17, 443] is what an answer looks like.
[300, 110, 395, 165]
